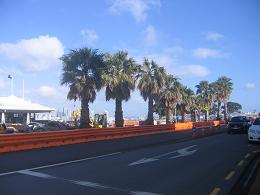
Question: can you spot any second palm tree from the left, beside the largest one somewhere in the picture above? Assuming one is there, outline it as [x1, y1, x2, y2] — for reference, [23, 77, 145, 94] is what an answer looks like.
[103, 51, 138, 127]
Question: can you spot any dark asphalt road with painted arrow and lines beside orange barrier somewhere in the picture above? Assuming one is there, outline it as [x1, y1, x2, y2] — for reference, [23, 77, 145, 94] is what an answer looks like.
[0, 133, 260, 195]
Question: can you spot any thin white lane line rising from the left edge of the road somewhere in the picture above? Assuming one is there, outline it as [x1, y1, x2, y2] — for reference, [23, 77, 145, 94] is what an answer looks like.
[0, 152, 121, 177]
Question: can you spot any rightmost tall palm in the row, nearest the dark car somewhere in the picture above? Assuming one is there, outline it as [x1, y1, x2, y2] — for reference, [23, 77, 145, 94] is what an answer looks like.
[216, 76, 233, 121]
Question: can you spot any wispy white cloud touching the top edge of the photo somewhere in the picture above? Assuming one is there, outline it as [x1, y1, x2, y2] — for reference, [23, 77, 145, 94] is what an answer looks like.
[109, 0, 161, 22]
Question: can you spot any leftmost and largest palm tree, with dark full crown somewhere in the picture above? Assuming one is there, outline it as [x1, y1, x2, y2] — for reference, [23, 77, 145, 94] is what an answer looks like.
[60, 48, 105, 128]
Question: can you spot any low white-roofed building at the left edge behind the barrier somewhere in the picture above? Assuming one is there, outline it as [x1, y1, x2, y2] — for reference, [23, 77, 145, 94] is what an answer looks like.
[0, 96, 54, 124]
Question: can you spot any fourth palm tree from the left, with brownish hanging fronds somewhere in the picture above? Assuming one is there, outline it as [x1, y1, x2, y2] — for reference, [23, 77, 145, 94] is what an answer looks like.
[159, 75, 181, 124]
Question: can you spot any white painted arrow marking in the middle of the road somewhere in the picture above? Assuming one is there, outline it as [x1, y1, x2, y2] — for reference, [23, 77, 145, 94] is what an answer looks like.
[128, 145, 197, 166]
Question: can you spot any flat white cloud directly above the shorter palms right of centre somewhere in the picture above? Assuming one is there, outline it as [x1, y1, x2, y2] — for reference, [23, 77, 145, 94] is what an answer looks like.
[174, 64, 210, 77]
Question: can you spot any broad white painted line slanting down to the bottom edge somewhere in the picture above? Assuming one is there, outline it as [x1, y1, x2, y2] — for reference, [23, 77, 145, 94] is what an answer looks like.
[17, 170, 159, 195]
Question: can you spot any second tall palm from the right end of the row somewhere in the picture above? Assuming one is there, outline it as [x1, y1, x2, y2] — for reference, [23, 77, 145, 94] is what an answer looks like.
[196, 81, 214, 121]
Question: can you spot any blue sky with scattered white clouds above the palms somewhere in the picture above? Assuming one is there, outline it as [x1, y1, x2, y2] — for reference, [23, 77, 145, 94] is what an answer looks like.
[0, 0, 260, 116]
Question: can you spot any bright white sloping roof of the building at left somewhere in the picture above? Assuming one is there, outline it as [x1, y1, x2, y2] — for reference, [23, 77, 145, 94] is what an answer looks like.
[0, 96, 55, 113]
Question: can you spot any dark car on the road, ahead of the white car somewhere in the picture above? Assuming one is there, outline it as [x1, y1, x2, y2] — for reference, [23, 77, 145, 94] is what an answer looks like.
[228, 116, 251, 133]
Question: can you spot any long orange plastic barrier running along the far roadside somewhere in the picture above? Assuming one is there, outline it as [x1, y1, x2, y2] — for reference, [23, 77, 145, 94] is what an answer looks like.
[0, 121, 223, 152]
